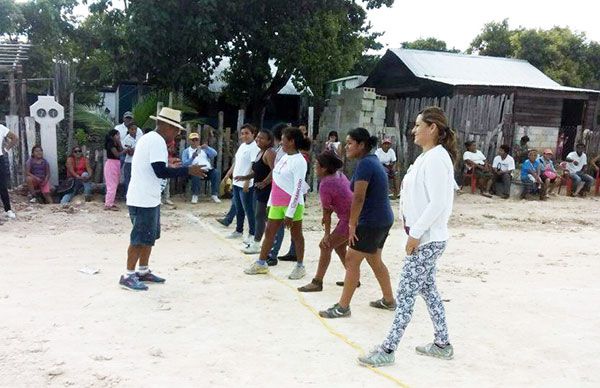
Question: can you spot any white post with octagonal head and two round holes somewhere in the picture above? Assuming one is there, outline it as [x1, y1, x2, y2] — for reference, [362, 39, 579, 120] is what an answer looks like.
[29, 96, 65, 186]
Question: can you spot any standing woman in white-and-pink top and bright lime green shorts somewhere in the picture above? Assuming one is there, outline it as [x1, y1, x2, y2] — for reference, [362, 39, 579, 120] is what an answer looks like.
[244, 128, 310, 280]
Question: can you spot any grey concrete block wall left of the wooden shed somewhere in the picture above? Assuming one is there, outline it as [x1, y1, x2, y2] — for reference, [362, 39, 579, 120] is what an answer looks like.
[319, 88, 387, 140]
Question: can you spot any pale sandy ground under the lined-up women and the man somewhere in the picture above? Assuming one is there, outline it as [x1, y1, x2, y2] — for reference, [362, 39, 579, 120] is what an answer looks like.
[0, 194, 600, 387]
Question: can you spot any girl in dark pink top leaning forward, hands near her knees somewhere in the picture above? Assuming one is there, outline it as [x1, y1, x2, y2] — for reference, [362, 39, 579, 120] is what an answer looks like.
[298, 152, 352, 292]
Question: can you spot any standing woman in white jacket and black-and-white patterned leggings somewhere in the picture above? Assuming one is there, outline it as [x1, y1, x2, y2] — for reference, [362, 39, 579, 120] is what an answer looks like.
[358, 107, 457, 367]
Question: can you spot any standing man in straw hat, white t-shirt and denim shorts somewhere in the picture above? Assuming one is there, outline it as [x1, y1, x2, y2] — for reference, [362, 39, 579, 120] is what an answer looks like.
[119, 108, 206, 290]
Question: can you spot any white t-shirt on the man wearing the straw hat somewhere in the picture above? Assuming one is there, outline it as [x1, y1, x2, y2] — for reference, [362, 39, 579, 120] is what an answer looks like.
[127, 131, 169, 208]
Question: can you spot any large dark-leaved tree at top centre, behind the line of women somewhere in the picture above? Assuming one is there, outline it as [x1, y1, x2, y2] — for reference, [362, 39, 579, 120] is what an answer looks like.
[215, 0, 393, 125]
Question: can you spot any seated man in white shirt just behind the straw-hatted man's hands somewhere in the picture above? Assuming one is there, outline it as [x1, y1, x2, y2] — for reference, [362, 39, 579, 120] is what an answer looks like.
[181, 132, 221, 203]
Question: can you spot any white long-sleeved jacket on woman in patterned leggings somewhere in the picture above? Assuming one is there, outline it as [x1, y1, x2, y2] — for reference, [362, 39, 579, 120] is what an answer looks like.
[400, 145, 456, 245]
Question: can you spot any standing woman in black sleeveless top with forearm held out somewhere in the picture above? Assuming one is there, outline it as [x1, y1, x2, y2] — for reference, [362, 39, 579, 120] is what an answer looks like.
[235, 129, 276, 254]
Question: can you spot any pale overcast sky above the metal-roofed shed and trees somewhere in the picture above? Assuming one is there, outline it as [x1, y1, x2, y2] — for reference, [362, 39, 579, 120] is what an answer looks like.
[369, 0, 600, 51]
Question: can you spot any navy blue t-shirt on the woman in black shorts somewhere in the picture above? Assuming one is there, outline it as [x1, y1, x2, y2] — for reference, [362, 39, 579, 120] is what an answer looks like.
[350, 154, 394, 227]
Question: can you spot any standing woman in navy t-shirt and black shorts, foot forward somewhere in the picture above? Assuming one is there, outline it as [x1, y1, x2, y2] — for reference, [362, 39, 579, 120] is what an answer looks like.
[319, 128, 396, 318]
